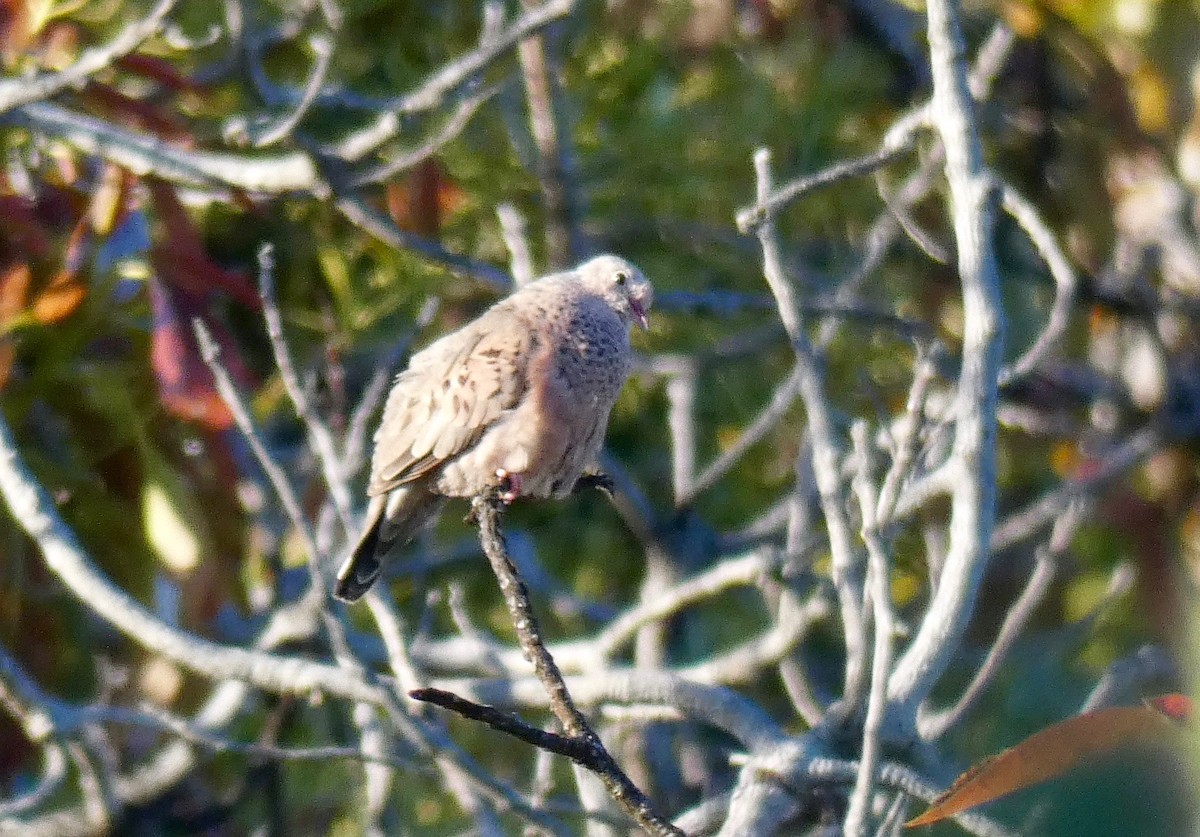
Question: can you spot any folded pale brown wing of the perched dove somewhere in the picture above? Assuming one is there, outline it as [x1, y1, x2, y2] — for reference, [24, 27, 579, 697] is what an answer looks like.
[367, 306, 545, 495]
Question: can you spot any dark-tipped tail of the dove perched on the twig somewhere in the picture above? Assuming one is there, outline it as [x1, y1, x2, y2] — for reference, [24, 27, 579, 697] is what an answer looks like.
[334, 484, 445, 602]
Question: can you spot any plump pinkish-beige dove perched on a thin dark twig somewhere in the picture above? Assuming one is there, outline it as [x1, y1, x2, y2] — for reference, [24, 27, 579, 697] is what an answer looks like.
[334, 255, 654, 602]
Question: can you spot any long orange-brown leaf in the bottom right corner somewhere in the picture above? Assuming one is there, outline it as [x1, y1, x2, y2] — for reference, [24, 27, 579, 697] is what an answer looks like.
[906, 706, 1170, 829]
